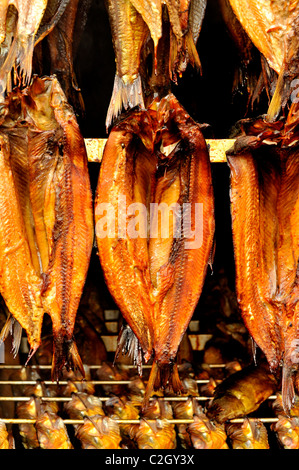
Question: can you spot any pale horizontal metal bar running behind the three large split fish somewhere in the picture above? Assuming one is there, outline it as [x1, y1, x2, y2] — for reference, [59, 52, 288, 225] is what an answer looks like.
[84, 139, 235, 163]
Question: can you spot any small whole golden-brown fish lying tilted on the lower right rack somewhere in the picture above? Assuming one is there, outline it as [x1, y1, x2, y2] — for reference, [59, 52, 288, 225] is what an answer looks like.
[206, 363, 278, 423]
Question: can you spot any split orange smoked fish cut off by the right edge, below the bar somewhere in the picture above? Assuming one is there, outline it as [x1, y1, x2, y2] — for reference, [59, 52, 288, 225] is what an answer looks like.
[228, 115, 299, 410]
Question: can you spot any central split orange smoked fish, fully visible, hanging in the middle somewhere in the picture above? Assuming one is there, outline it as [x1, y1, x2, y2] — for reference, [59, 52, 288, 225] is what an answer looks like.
[95, 94, 214, 400]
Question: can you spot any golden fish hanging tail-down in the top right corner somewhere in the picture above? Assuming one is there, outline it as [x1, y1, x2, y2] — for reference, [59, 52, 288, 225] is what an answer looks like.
[229, 0, 299, 121]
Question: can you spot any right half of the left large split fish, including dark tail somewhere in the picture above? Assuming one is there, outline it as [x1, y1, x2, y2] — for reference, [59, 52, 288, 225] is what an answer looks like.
[37, 79, 93, 376]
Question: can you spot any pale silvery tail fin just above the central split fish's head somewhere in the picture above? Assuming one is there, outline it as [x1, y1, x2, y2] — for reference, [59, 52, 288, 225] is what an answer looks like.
[106, 74, 144, 132]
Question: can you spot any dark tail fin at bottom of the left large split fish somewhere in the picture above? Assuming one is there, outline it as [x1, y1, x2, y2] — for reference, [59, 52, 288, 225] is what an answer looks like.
[51, 335, 85, 382]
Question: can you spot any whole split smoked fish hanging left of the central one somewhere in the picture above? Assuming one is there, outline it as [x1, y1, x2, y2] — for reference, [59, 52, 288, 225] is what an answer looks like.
[0, 77, 93, 379]
